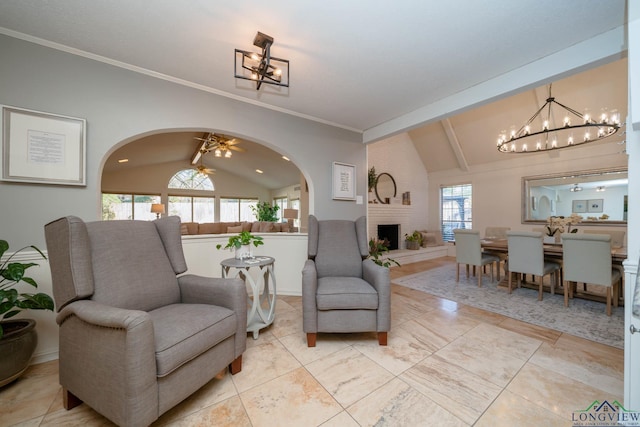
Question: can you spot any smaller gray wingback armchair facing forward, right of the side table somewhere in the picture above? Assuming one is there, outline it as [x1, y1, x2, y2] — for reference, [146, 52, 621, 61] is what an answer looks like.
[302, 215, 391, 347]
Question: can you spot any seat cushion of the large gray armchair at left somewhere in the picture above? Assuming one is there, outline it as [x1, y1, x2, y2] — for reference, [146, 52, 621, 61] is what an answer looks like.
[149, 304, 237, 377]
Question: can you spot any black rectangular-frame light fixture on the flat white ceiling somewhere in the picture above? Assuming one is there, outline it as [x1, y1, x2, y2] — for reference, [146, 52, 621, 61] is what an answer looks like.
[234, 31, 289, 90]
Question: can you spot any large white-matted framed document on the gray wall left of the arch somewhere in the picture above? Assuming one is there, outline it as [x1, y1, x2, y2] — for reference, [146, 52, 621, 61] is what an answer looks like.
[0, 105, 86, 186]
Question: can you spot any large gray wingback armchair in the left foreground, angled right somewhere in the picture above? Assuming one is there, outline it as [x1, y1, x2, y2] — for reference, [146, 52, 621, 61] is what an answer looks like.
[45, 216, 247, 426]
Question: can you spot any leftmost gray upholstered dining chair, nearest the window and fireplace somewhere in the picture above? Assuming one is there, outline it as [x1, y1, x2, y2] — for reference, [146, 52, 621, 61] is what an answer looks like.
[453, 228, 500, 287]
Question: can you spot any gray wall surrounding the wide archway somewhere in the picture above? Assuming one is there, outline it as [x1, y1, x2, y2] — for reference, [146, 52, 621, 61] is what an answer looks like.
[0, 35, 367, 248]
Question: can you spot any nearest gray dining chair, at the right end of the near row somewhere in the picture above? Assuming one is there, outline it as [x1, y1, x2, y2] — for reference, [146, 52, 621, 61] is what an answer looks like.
[562, 233, 622, 316]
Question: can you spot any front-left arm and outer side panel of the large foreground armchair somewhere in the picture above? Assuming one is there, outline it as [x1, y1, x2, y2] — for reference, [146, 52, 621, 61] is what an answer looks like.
[56, 300, 159, 425]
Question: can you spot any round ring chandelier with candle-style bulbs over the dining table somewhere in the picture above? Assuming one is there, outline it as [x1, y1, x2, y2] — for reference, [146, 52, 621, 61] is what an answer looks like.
[498, 85, 620, 154]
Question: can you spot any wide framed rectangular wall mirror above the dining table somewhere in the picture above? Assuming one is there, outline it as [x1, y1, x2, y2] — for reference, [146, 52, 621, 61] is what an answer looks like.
[522, 168, 629, 225]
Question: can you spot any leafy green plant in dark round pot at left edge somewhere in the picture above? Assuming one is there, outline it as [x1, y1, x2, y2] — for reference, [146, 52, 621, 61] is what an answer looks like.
[0, 240, 53, 387]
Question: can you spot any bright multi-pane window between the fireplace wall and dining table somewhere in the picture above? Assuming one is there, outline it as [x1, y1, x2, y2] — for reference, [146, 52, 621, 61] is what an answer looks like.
[440, 184, 472, 241]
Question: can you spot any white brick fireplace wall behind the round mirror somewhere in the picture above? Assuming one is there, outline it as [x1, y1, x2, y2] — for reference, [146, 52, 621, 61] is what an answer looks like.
[367, 133, 429, 248]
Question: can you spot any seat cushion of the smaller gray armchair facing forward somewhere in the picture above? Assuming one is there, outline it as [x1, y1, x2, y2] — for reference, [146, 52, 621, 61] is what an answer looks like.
[316, 277, 378, 310]
